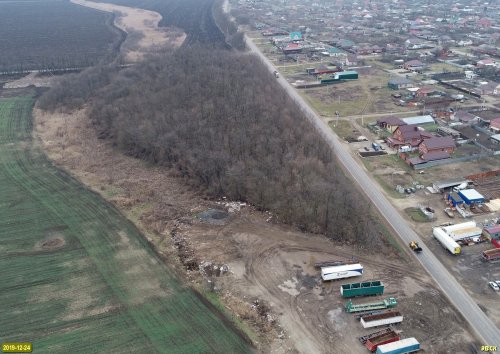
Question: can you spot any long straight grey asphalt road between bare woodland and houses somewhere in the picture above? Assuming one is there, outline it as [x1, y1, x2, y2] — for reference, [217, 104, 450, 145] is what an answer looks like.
[247, 36, 500, 346]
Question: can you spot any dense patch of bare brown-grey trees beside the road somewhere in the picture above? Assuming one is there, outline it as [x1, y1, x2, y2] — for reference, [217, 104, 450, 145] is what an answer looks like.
[42, 47, 378, 246]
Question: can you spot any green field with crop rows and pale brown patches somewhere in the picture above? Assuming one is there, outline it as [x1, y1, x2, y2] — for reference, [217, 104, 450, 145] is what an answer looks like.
[0, 96, 250, 353]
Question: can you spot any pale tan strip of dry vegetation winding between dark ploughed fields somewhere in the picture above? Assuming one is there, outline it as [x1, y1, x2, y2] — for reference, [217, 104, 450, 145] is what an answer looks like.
[71, 0, 186, 63]
